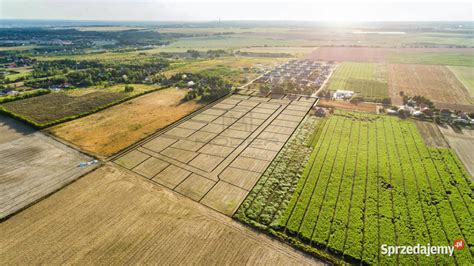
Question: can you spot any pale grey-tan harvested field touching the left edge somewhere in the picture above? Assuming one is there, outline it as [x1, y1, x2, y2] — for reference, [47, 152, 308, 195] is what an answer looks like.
[0, 115, 93, 219]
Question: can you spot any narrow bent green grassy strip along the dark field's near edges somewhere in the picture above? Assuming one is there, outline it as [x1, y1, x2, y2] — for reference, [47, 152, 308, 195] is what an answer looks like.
[0, 87, 167, 129]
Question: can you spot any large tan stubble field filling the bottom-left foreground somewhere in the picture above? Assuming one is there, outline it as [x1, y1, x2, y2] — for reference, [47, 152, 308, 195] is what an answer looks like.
[0, 165, 318, 265]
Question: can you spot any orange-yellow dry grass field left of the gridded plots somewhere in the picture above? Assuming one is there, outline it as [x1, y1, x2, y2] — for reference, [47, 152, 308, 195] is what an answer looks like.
[46, 88, 201, 157]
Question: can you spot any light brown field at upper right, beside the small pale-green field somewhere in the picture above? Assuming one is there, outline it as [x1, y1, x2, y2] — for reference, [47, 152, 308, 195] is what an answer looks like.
[388, 64, 471, 106]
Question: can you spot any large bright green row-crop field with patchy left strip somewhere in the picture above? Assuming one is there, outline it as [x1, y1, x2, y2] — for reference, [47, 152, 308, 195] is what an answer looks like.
[236, 111, 474, 265]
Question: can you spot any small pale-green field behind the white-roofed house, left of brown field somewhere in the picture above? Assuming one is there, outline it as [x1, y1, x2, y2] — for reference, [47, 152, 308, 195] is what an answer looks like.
[328, 62, 388, 101]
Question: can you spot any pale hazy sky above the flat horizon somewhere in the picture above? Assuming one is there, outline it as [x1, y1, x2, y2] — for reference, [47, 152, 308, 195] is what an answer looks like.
[0, 0, 474, 22]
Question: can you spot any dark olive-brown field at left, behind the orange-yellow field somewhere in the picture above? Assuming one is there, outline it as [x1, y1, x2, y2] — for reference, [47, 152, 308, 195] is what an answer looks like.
[0, 84, 159, 127]
